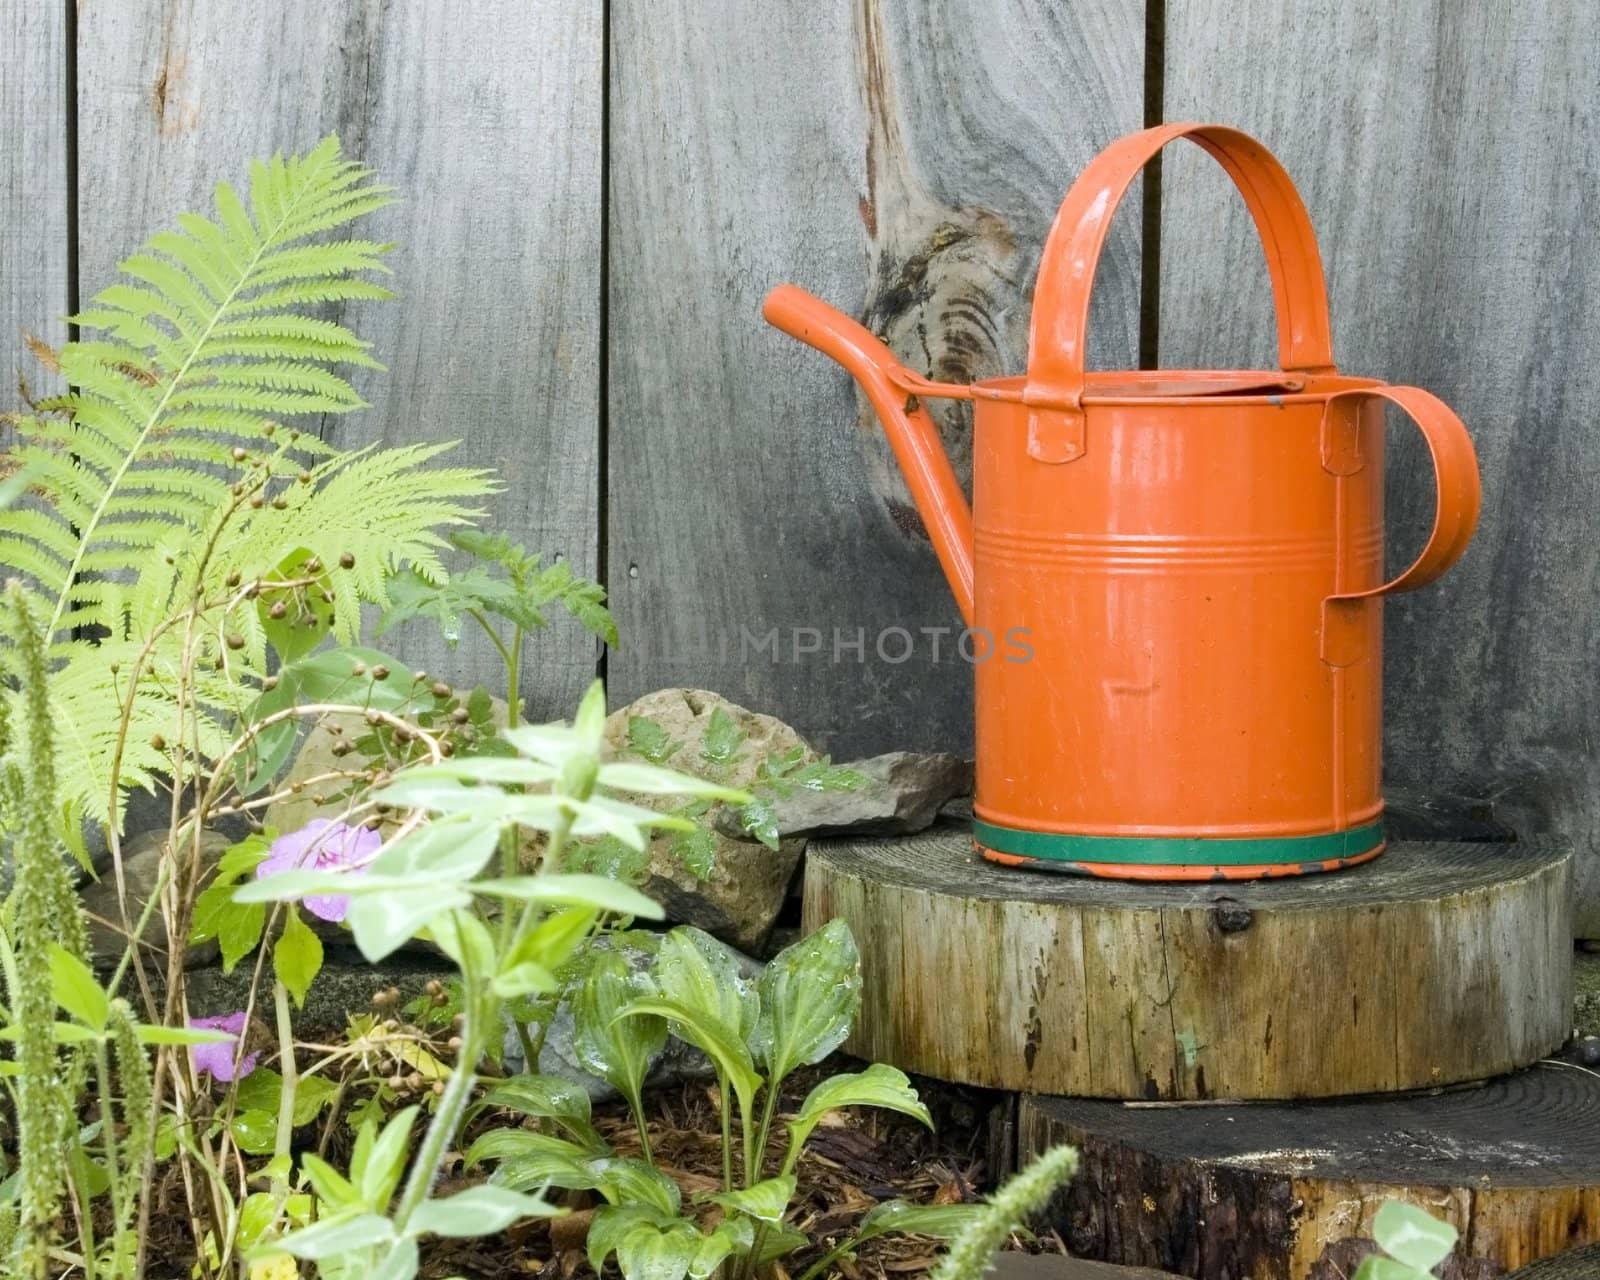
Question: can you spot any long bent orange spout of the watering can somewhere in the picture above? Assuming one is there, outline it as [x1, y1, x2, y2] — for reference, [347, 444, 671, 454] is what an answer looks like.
[762, 285, 973, 626]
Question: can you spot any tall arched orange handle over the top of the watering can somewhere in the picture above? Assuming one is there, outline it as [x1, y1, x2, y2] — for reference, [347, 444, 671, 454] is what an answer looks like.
[1022, 122, 1334, 462]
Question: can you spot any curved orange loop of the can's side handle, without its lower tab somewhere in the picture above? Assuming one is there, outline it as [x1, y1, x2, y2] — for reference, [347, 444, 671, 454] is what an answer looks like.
[1328, 387, 1483, 602]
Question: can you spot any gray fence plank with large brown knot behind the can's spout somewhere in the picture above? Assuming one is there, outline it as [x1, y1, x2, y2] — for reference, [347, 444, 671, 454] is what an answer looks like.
[608, 0, 1144, 754]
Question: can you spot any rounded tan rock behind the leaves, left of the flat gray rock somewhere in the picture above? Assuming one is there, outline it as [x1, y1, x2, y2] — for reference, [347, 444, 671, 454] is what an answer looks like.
[605, 690, 813, 952]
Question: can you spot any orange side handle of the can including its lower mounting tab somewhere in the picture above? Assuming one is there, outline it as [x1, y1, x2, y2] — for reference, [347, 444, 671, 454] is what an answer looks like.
[1322, 387, 1483, 667]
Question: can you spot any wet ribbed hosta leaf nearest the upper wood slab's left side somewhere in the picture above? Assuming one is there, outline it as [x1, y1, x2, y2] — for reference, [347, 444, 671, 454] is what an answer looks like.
[750, 920, 861, 1088]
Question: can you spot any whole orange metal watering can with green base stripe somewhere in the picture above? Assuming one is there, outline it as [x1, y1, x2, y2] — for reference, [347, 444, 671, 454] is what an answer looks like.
[765, 123, 1478, 880]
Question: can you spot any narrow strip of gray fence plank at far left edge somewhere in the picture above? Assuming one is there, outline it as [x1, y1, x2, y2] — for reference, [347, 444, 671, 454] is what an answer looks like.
[0, 0, 69, 404]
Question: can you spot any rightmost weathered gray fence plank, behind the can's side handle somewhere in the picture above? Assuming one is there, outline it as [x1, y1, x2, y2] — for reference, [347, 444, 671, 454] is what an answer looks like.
[1162, 0, 1600, 936]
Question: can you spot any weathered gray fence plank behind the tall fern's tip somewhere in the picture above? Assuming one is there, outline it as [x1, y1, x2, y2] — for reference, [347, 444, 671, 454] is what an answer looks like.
[78, 0, 602, 714]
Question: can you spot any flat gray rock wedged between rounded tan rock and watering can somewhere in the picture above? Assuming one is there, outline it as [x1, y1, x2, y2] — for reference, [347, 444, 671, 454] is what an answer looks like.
[715, 750, 973, 837]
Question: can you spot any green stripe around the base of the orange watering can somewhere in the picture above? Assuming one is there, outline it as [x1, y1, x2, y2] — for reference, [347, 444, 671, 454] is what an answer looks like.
[973, 818, 1384, 867]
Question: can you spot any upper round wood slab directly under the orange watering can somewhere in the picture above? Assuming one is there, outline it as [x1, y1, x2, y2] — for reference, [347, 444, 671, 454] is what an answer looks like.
[805, 826, 1573, 1099]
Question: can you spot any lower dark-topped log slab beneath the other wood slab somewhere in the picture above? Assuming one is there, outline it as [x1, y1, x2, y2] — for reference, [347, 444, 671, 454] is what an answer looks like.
[1018, 1062, 1600, 1280]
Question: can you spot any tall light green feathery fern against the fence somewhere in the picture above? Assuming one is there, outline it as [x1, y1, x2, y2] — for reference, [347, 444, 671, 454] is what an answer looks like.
[0, 138, 490, 824]
